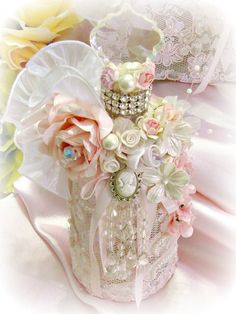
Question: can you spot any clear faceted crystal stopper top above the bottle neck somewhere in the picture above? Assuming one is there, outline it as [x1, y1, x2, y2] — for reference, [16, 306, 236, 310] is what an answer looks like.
[90, 4, 164, 64]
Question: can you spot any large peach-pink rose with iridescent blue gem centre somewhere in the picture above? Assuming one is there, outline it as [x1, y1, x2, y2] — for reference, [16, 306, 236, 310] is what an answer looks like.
[38, 95, 112, 180]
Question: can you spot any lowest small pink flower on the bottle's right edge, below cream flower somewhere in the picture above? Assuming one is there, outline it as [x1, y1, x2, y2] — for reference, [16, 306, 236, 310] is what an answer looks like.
[161, 202, 194, 238]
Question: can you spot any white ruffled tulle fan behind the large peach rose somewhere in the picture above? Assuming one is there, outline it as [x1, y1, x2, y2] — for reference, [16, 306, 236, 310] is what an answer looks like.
[3, 41, 106, 198]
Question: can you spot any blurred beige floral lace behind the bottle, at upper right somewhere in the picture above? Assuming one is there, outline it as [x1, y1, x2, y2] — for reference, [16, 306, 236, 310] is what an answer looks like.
[80, 0, 236, 92]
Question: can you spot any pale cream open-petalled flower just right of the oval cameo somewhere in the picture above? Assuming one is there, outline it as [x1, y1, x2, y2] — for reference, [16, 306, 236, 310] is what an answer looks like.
[143, 162, 189, 203]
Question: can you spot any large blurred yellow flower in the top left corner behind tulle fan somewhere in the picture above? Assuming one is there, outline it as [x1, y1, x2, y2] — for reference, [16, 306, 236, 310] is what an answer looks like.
[0, 0, 82, 70]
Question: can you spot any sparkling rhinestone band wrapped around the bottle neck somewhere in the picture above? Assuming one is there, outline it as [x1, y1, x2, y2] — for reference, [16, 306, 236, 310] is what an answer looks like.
[102, 86, 151, 116]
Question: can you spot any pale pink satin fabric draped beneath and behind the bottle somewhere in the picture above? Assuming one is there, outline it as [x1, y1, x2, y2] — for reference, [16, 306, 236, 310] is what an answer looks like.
[0, 82, 236, 314]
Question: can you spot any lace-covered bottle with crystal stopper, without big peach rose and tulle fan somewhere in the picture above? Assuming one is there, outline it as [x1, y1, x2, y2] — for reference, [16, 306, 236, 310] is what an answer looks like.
[69, 6, 194, 303]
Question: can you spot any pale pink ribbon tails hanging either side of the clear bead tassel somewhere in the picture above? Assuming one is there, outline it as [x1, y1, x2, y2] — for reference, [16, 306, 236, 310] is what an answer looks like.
[81, 170, 156, 308]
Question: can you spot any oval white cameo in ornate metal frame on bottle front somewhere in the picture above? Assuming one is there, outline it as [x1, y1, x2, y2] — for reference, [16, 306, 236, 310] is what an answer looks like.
[112, 169, 139, 200]
